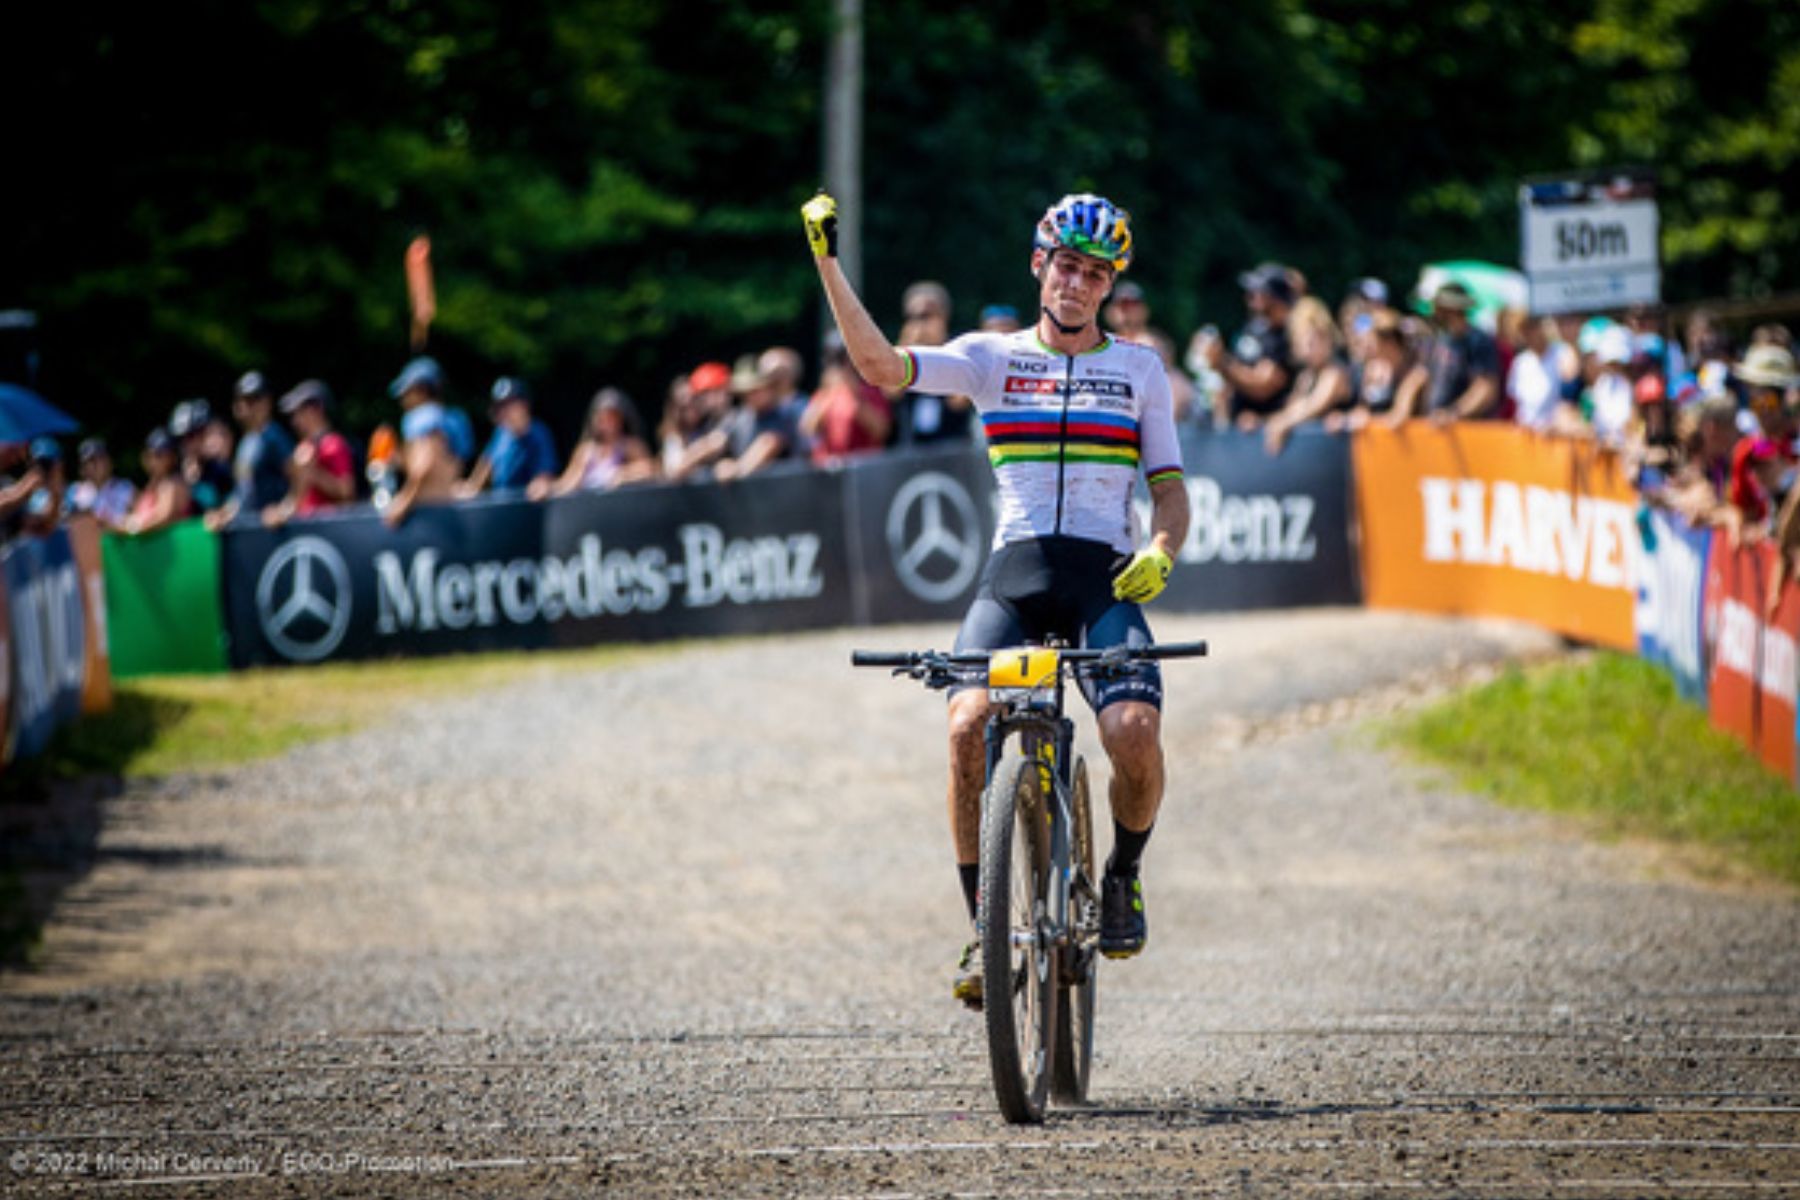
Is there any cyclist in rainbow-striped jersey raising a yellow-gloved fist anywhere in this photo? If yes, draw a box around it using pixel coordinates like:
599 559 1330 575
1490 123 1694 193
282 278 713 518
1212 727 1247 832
801 193 1188 1007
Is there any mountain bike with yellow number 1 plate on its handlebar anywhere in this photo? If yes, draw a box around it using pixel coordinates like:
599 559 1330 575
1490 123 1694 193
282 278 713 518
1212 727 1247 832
850 642 1206 1124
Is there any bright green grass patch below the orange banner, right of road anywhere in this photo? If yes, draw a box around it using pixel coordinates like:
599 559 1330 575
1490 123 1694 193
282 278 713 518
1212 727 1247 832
1395 651 1800 885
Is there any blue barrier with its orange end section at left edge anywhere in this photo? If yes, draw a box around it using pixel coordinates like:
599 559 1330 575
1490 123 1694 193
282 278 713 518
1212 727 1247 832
0 518 112 761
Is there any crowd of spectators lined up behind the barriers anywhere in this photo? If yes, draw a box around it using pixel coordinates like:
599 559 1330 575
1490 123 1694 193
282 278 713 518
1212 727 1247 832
10 263 1800 568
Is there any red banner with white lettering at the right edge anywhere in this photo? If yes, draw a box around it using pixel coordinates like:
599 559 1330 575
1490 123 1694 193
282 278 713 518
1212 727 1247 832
1705 531 1800 781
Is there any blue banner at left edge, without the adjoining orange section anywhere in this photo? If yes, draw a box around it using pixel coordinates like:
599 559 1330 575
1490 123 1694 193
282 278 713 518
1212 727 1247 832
0 529 88 759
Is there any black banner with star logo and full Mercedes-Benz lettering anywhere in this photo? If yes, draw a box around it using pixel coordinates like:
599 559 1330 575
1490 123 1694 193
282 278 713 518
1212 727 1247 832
223 471 850 666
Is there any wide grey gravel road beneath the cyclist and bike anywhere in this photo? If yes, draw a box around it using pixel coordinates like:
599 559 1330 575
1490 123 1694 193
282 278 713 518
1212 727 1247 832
0 610 1800 1198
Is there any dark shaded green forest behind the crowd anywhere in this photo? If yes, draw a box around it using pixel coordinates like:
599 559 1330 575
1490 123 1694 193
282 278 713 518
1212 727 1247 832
0 0 1800 446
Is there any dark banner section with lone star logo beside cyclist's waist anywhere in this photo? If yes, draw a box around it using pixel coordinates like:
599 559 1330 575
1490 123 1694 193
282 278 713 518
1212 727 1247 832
842 448 994 624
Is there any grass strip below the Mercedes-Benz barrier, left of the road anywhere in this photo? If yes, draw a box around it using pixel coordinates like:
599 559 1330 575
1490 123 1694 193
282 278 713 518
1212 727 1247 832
7 644 673 788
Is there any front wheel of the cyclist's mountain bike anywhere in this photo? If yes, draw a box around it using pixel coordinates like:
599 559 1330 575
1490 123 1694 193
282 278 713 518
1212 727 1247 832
977 750 1057 1124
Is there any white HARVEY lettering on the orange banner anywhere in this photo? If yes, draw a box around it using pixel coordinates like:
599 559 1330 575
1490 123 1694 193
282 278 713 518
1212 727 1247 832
1418 477 1640 592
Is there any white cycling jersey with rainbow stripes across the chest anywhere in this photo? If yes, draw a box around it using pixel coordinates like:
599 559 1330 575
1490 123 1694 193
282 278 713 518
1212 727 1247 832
902 329 1181 554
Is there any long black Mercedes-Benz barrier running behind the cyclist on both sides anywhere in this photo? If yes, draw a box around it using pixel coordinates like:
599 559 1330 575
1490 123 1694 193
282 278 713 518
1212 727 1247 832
220 435 1359 667
